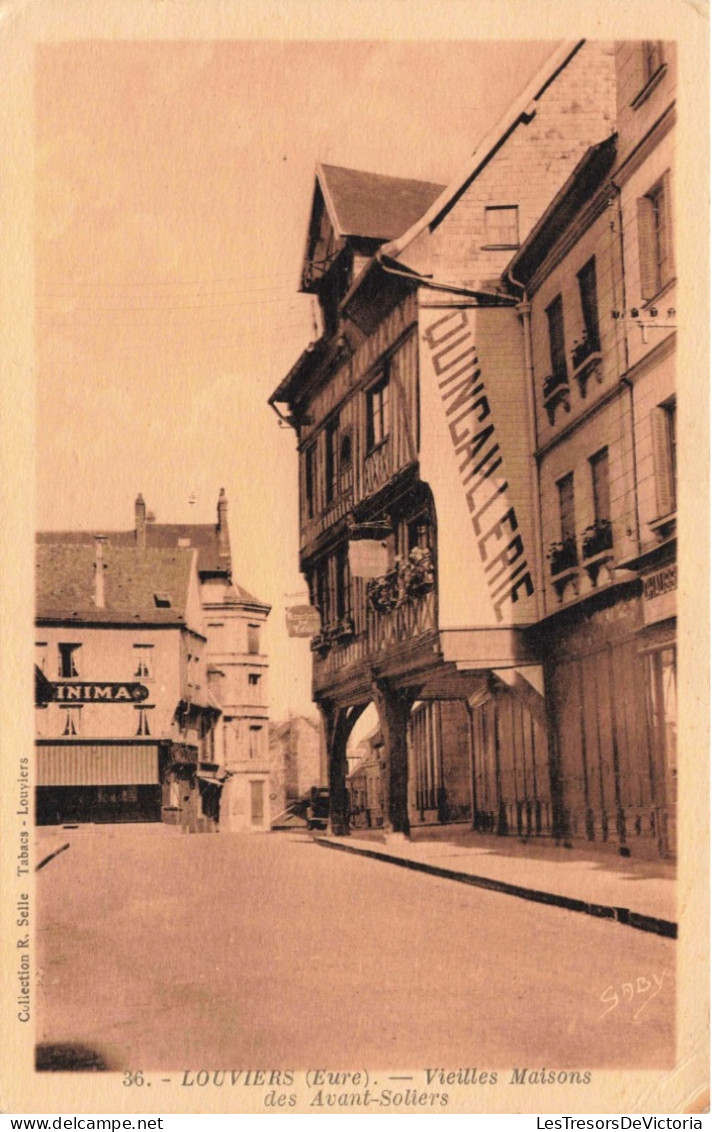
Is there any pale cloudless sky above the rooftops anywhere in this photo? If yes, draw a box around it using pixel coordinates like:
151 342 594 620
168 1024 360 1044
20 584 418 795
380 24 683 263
34 40 556 719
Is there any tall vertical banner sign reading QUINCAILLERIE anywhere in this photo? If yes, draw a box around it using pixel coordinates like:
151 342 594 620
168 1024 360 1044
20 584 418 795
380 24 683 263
420 307 537 629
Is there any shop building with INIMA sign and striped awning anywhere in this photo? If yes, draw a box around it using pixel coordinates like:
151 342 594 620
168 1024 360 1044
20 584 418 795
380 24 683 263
35 538 213 829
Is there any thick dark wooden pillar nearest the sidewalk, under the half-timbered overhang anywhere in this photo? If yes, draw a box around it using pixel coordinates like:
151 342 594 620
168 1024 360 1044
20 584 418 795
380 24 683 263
372 680 418 838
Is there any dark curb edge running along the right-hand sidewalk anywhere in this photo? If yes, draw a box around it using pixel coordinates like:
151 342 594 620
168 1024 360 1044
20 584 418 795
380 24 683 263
315 838 677 940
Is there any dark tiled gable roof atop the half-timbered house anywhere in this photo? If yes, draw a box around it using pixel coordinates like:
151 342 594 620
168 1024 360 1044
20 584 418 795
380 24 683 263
319 165 444 240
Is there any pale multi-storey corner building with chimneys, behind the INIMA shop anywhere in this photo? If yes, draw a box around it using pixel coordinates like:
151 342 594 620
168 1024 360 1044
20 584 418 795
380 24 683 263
37 490 269 832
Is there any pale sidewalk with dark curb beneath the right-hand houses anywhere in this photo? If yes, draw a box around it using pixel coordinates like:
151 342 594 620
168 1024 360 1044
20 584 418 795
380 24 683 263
317 825 677 938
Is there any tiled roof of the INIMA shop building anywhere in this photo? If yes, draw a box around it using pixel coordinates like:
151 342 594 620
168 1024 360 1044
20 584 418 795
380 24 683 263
36 541 195 625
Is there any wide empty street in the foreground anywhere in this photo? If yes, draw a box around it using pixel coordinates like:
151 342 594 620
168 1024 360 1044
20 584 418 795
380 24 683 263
35 825 676 1071
